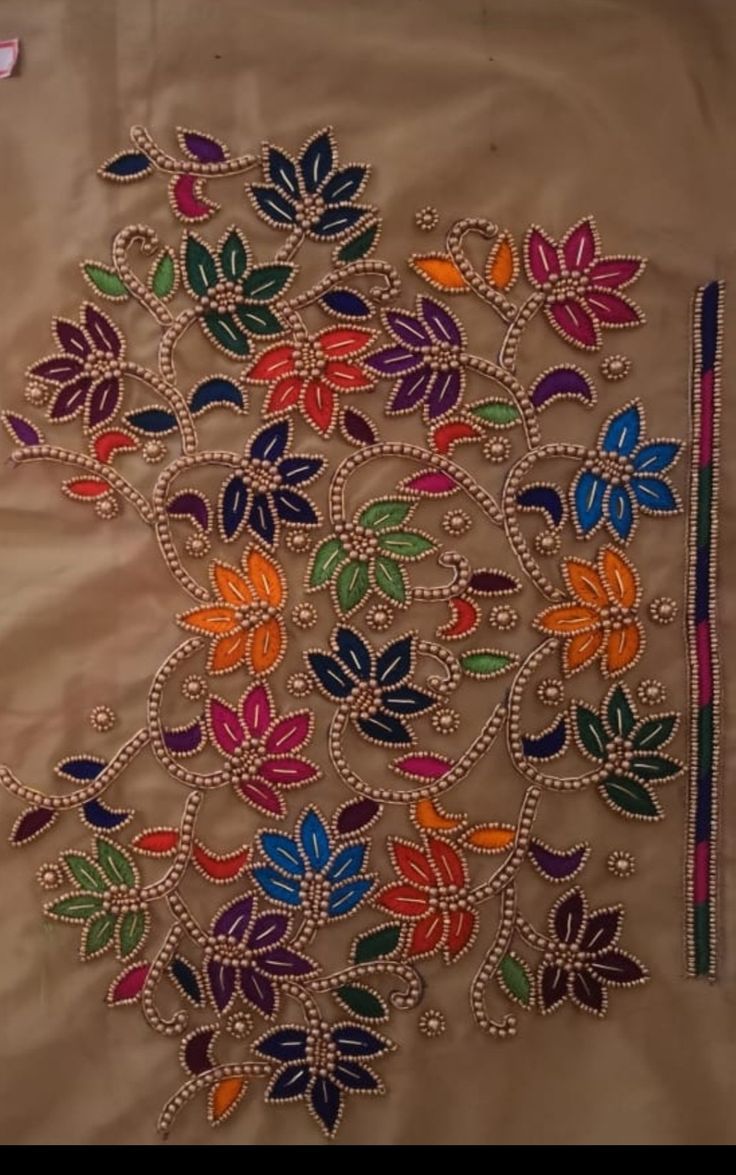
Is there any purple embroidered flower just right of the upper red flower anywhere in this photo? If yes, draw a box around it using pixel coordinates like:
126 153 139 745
363 295 466 423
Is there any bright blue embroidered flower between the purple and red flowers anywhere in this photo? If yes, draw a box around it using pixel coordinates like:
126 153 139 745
253 808 375 921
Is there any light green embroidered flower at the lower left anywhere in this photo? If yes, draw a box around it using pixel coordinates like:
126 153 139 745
46 837 150 960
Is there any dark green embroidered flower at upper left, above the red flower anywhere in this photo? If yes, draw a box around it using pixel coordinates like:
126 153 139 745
182 227 295 358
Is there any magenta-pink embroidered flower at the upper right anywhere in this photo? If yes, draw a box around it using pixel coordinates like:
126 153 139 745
524 217 645 351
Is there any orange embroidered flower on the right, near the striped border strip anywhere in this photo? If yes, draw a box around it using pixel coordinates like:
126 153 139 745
535 546 644 677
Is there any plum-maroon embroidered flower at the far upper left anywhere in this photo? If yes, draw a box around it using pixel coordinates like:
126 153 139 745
28 303 125 429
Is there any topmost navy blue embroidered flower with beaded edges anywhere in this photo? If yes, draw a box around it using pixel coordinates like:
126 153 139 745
248 130 372 241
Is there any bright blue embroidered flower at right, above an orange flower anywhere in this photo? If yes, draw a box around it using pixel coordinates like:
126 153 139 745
570 402 682 543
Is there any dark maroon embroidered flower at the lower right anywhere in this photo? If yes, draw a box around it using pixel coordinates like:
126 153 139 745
537 888 649 1016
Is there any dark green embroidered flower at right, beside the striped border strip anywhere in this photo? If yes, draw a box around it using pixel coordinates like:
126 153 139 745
574 685 683 820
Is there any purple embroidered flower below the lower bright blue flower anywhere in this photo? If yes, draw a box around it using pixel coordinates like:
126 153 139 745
205 894 315 1019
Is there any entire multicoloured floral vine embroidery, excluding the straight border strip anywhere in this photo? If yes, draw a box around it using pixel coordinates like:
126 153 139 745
0 127 684 1137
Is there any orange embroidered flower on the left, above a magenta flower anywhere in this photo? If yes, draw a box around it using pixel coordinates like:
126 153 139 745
178 548 286 677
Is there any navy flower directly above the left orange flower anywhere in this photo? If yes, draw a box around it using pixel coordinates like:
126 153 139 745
218 421 324 546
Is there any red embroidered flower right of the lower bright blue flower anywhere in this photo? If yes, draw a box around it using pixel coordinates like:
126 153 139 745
376 837 477 962
